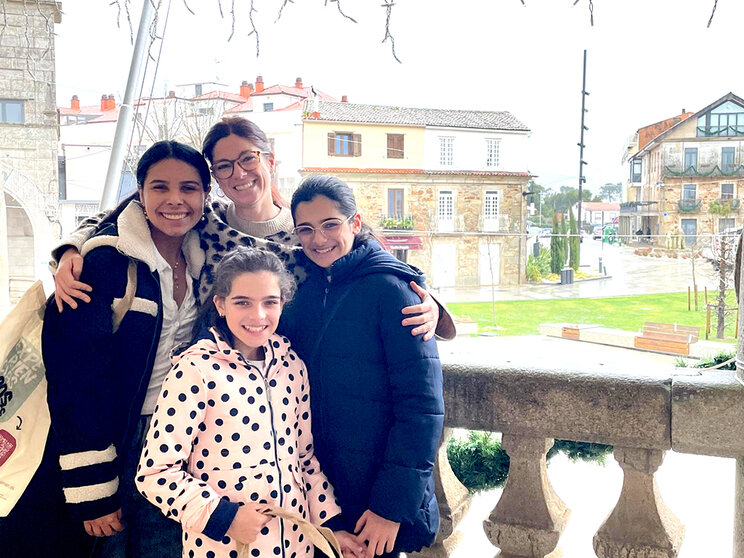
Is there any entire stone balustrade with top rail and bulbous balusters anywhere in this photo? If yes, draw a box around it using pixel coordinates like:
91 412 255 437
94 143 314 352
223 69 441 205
415 358 744 558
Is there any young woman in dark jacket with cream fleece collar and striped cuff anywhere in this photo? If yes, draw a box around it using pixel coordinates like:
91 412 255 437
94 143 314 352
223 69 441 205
42 141 210 558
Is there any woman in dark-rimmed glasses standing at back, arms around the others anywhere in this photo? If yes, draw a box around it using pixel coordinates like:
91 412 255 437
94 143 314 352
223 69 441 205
55 117 448 339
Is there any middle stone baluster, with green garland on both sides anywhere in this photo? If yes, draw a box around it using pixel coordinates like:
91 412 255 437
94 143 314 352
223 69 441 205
483 433 570 558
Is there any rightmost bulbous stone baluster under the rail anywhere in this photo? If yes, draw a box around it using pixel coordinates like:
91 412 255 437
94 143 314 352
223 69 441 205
594 447 685 558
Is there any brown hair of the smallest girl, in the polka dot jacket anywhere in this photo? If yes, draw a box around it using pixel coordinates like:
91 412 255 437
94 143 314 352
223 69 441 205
193 246 297 346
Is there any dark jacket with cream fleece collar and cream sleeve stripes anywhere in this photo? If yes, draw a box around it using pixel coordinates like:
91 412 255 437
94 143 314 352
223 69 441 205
42 201 204 520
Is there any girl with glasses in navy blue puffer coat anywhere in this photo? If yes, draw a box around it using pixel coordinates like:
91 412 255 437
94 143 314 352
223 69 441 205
282 176 444 556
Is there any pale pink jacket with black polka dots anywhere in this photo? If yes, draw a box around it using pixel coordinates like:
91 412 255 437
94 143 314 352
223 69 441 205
136 330 341 558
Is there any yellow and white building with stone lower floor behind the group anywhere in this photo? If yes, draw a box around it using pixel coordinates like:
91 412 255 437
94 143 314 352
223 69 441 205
302 102 530 288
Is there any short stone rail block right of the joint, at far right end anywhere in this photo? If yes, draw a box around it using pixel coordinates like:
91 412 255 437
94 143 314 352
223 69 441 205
672 370 744 457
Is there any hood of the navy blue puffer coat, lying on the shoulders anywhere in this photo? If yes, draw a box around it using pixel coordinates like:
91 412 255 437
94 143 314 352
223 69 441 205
315 239 426 287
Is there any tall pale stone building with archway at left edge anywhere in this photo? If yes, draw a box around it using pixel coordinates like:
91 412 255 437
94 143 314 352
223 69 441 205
0 0 61 304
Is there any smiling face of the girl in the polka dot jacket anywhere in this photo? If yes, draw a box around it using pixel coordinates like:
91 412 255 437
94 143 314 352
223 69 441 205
213 271 283 360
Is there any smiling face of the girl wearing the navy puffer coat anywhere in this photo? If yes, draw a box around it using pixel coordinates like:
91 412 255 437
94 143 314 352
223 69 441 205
294 196 362 267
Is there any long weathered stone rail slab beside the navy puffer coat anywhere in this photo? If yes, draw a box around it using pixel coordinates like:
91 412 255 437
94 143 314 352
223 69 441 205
444 356 671 449
